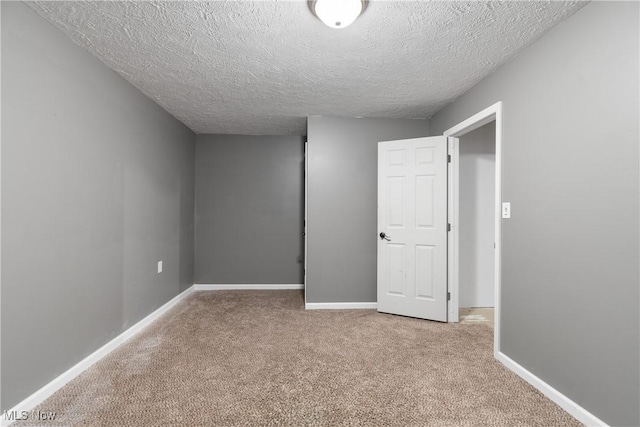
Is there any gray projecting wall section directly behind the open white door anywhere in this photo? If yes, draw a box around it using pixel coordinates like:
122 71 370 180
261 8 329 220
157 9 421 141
306 116 428 303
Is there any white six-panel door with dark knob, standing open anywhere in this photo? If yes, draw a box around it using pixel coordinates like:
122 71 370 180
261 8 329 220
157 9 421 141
377 136 447 322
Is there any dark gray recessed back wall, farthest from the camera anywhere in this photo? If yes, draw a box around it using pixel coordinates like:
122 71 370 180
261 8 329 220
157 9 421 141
195 135 304 284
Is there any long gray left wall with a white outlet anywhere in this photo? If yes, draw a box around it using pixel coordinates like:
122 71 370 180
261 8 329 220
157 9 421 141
0 2 195 411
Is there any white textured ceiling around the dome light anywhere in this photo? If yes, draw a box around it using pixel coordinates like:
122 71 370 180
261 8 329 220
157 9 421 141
28 0 585 135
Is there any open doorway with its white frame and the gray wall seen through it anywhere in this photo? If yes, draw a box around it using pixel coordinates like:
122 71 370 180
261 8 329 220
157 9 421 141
444 102 502 355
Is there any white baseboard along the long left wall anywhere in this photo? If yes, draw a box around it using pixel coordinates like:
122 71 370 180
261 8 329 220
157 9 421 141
0 286 193 426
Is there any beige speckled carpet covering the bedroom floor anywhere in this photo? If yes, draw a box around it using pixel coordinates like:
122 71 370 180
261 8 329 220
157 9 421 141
15 291 581 426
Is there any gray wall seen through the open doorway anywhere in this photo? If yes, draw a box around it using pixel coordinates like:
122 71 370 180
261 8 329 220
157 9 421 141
458 122 496 307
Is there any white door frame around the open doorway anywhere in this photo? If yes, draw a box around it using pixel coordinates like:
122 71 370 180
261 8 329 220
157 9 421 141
444 102 502 357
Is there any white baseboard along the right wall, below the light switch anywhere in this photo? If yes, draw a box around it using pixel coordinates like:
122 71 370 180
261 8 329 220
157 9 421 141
497 352 607 427
